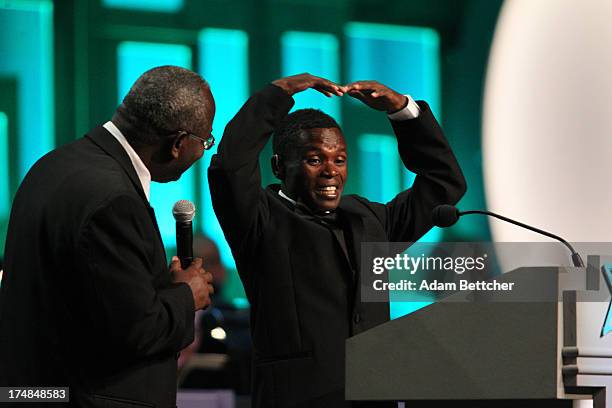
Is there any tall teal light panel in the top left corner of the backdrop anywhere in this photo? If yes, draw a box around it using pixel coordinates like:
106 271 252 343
0 0 55 179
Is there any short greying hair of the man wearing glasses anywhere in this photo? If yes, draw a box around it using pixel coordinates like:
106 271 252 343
117 65 214 145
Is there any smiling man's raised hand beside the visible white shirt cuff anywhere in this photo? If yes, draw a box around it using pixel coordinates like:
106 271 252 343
343 81 408 113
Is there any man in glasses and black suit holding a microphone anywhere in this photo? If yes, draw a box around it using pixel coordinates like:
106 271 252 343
0 66 215 407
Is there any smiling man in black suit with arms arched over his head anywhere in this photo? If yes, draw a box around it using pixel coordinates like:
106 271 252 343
209 74 466 407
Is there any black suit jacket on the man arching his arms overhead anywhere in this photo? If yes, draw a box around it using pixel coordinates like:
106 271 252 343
209 85 465 408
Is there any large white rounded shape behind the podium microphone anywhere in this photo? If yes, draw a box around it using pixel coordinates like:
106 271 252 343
483 0 612 242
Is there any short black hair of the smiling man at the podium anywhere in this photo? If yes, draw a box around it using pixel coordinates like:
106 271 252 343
272 109 340 157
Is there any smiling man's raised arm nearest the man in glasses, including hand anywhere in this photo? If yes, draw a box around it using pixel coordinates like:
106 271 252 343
208 74 342 251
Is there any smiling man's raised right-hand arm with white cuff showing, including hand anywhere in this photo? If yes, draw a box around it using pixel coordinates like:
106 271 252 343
345 81 466 242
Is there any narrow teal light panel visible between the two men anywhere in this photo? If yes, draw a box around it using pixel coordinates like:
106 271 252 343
198 28 249 270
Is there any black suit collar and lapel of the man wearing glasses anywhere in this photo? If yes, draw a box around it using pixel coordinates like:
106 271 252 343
85 126 164 248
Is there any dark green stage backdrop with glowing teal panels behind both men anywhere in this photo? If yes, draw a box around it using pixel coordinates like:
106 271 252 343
0 0 501 317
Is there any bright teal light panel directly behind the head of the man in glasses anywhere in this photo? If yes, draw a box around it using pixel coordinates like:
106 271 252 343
117 42 191 248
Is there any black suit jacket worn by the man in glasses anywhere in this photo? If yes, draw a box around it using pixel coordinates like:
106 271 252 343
0 127 194 407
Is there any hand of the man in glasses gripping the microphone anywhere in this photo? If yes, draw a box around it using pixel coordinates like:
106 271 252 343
170 256 214 310
